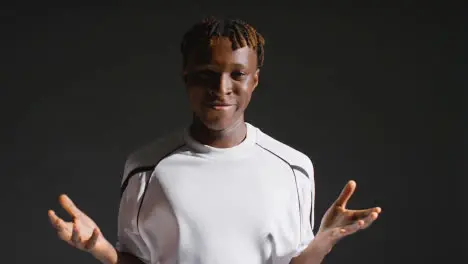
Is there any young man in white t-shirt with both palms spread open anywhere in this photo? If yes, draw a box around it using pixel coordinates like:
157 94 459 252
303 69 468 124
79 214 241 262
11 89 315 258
49 17 381 264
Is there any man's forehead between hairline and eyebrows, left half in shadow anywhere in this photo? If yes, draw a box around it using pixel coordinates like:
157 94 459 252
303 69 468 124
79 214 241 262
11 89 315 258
187 37 257 69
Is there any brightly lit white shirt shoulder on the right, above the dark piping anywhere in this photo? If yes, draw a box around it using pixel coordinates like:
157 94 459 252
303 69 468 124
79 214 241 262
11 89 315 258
252 124 314 179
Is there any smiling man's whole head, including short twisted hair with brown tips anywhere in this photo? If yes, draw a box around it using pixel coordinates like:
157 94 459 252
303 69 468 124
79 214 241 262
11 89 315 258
181 17 265 130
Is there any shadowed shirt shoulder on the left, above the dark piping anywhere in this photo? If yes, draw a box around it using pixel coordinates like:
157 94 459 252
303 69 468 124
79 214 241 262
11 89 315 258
122 131 185 185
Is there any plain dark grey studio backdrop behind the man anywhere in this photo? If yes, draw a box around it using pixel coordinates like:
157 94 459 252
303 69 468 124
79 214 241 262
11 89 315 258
0 2 468 264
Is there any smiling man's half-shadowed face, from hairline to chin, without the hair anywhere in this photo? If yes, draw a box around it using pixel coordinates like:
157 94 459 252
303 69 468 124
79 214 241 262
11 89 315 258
184 37 259 130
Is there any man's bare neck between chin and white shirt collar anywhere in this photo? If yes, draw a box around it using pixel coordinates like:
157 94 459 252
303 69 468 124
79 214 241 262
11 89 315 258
190 118 247 148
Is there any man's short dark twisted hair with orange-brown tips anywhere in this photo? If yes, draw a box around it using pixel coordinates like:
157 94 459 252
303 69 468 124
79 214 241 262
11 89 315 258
180 16 265 68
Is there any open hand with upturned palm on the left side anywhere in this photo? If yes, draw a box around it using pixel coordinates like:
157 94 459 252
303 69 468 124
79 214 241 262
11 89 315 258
48 194 118 263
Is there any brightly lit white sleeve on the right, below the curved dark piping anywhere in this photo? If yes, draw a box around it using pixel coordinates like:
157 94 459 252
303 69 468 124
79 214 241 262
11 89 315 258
296 158 315 256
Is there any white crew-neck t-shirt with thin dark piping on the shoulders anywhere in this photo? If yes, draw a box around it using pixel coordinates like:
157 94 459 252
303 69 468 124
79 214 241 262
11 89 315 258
117 123 315 264
